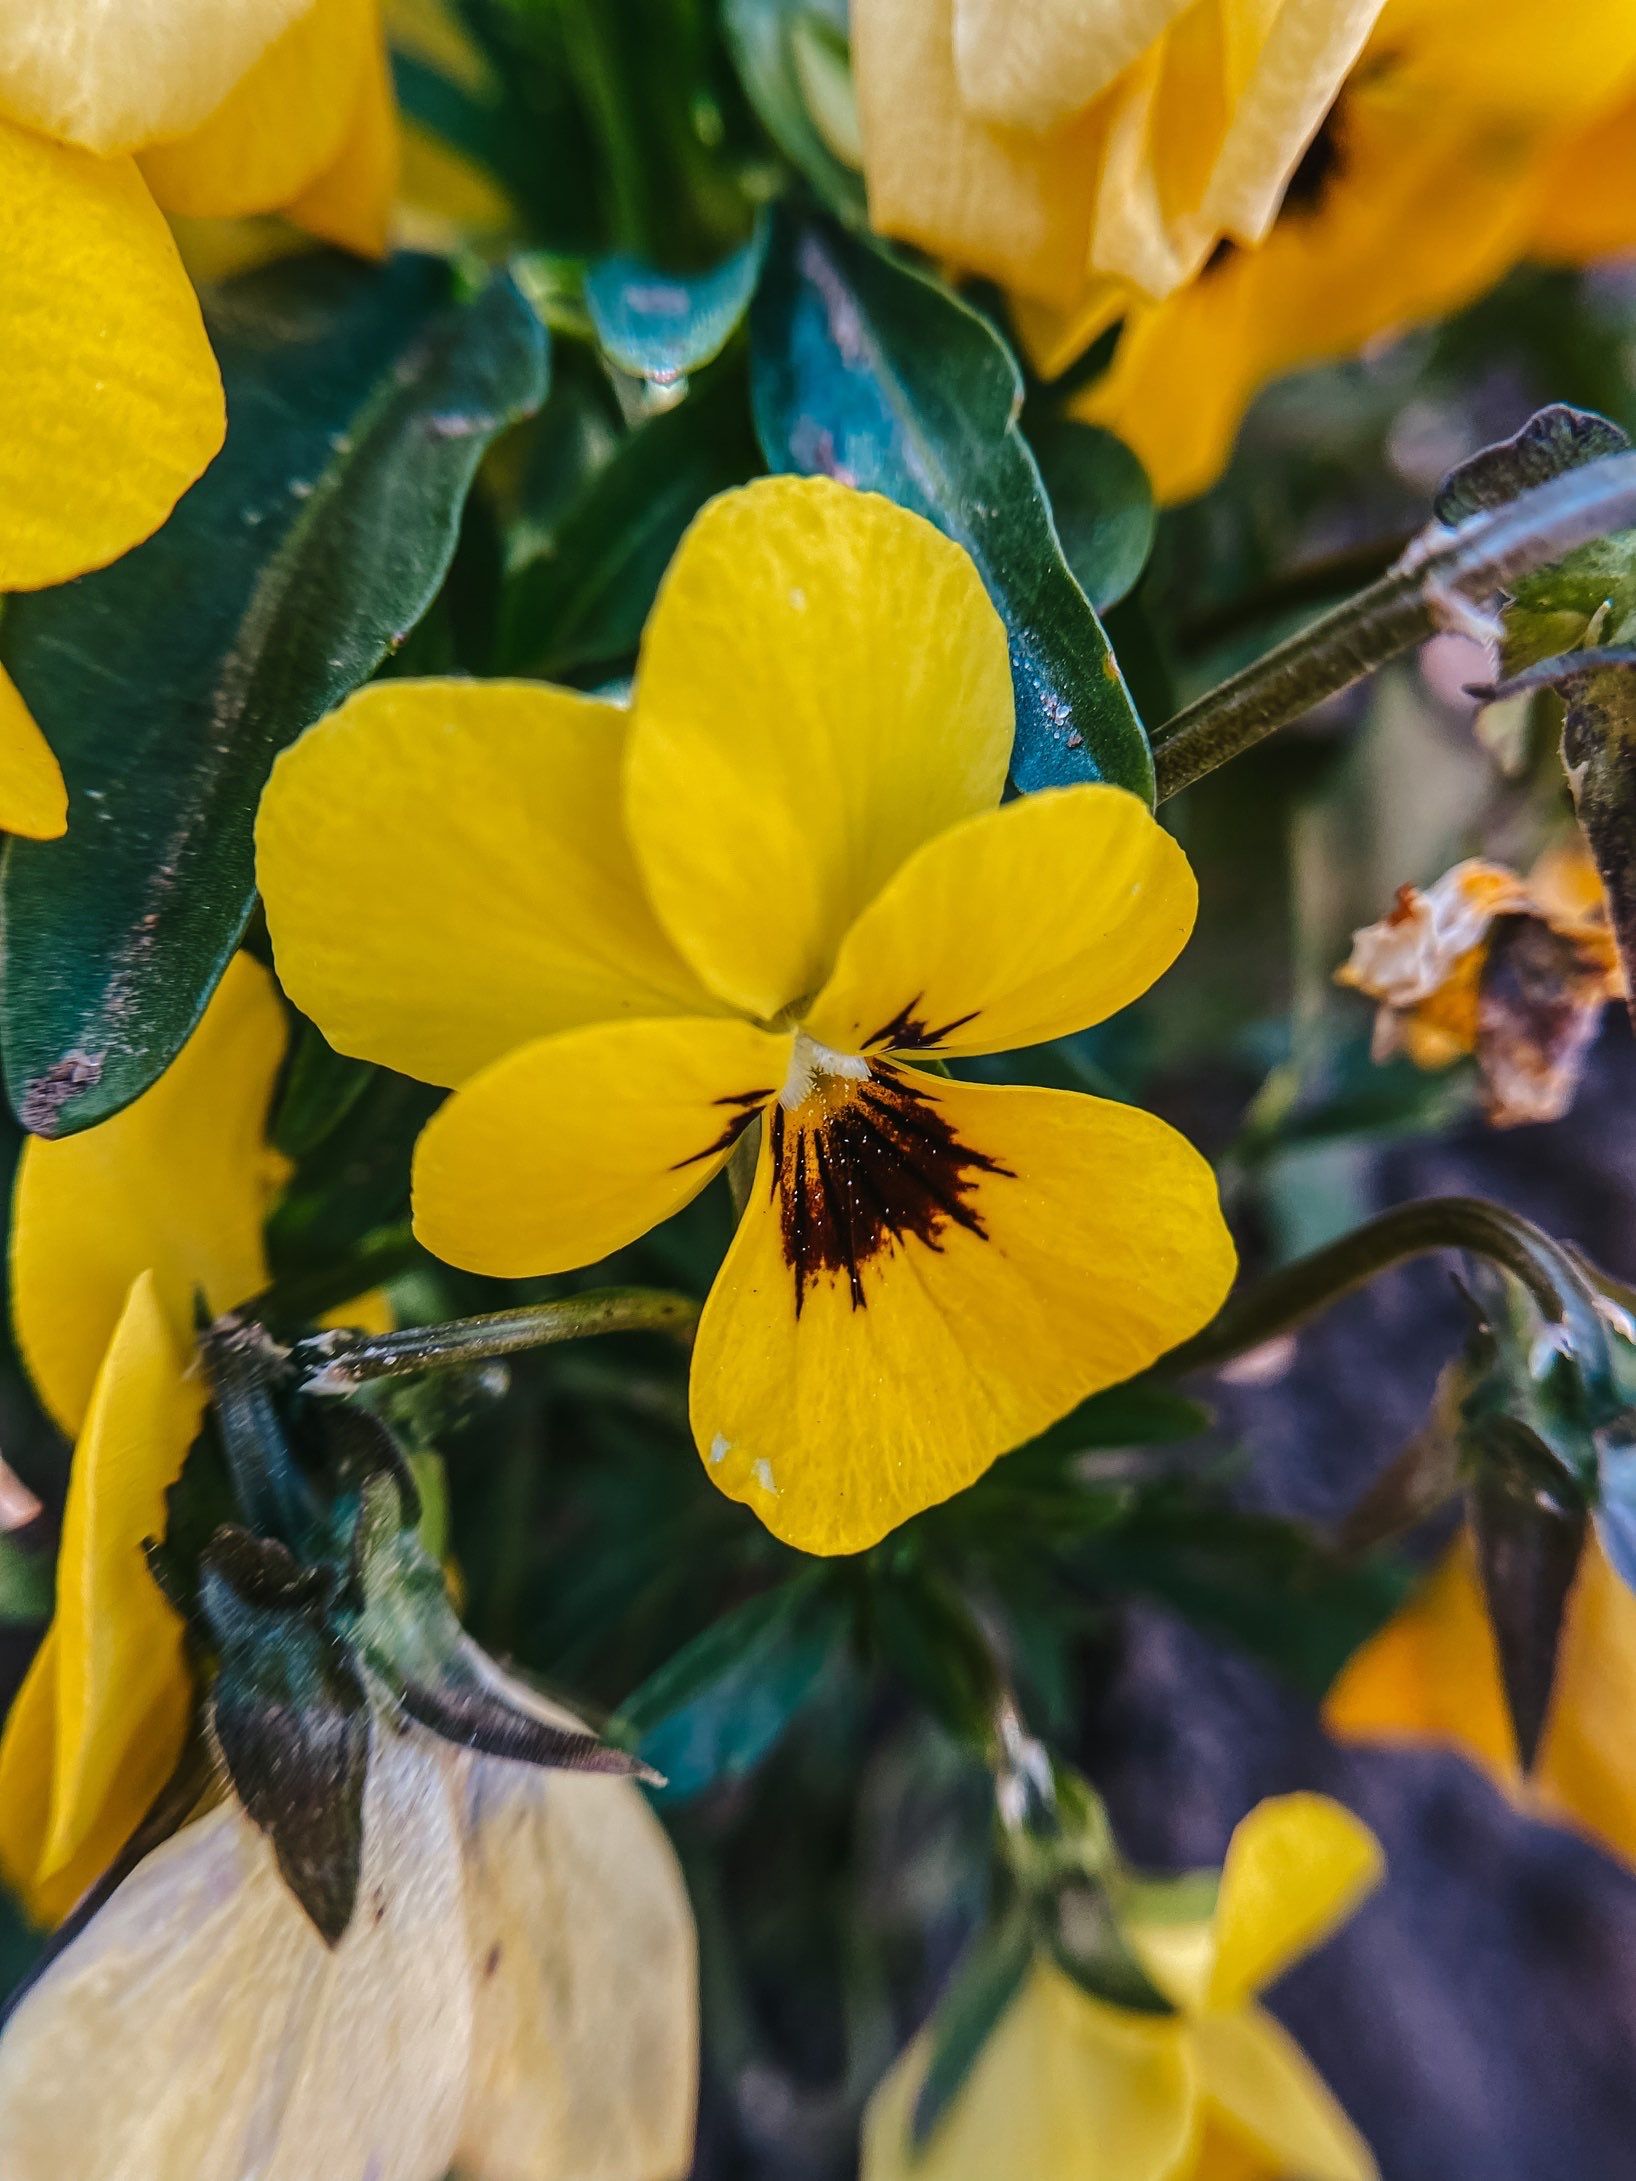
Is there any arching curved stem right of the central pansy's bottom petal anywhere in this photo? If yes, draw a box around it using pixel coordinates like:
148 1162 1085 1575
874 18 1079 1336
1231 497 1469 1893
1165 1197 1605 1372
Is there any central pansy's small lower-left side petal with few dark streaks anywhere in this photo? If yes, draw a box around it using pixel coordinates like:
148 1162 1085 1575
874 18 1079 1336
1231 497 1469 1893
414 1021 792 1280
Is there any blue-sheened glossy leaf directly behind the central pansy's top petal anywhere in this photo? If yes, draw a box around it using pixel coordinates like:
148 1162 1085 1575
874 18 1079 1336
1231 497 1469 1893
750 220 1154 803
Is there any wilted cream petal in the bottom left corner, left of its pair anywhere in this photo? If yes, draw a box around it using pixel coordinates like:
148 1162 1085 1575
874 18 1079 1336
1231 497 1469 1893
0 1727 471 2181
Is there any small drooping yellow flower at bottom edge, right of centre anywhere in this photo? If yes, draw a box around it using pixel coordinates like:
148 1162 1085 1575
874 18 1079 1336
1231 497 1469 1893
862 1795 1383 2181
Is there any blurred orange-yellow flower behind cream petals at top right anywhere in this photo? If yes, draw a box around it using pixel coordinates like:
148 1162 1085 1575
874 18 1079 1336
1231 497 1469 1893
1077 0 1636 502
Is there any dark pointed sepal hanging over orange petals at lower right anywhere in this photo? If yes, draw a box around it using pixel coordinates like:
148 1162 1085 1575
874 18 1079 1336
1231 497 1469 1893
1470 1429 1586 1771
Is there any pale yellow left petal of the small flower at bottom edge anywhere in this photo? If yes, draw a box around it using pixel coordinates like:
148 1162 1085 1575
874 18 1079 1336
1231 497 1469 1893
862 1967 1195 2181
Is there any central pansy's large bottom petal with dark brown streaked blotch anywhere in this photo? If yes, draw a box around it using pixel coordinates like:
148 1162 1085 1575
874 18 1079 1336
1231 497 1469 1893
691 1064 1232 1553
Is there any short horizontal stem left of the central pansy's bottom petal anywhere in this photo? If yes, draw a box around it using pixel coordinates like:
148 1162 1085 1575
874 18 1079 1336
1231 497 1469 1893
290 1287 698 1394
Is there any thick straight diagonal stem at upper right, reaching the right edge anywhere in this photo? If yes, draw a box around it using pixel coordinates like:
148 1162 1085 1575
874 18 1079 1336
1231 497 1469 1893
1154 451 1636 803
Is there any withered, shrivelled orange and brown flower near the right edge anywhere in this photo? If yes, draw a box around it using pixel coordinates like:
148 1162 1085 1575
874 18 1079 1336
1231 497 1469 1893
1335 833 1625 1128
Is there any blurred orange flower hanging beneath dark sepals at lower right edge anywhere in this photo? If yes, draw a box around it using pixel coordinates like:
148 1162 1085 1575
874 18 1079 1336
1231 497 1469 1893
1324 1531 1636 1867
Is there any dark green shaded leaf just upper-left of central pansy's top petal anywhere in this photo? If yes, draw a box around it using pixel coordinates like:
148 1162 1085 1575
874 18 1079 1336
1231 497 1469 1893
500 360 757 678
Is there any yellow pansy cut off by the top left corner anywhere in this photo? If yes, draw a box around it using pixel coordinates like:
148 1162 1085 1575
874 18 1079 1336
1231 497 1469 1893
0 0 395 838
